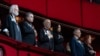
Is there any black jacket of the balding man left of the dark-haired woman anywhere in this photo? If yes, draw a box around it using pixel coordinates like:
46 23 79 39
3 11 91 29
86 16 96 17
39 28 54 50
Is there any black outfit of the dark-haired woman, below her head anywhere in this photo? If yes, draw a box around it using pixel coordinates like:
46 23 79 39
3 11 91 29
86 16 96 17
54 33 65 53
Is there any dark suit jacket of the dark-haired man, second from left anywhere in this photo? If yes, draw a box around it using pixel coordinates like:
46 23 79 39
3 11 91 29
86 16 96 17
20 22 36 45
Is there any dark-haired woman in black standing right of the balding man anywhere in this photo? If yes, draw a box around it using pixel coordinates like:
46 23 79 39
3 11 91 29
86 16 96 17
54 25 65 53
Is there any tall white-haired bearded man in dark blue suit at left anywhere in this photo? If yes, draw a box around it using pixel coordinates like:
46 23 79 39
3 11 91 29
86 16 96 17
3 4 22 41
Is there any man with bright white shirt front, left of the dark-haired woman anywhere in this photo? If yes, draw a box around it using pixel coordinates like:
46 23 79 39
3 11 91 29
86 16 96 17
39 19 54 51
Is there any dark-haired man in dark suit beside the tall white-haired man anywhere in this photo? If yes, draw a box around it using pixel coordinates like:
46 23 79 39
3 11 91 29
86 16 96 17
20 12 37 45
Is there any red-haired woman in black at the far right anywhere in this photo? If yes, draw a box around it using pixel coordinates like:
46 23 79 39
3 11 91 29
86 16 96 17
84 35 96 56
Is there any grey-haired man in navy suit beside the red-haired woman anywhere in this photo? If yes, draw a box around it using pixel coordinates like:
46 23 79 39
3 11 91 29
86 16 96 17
70 28 85 56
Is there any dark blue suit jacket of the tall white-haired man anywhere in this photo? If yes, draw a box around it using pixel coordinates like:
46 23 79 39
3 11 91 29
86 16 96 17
4 14 22 41
